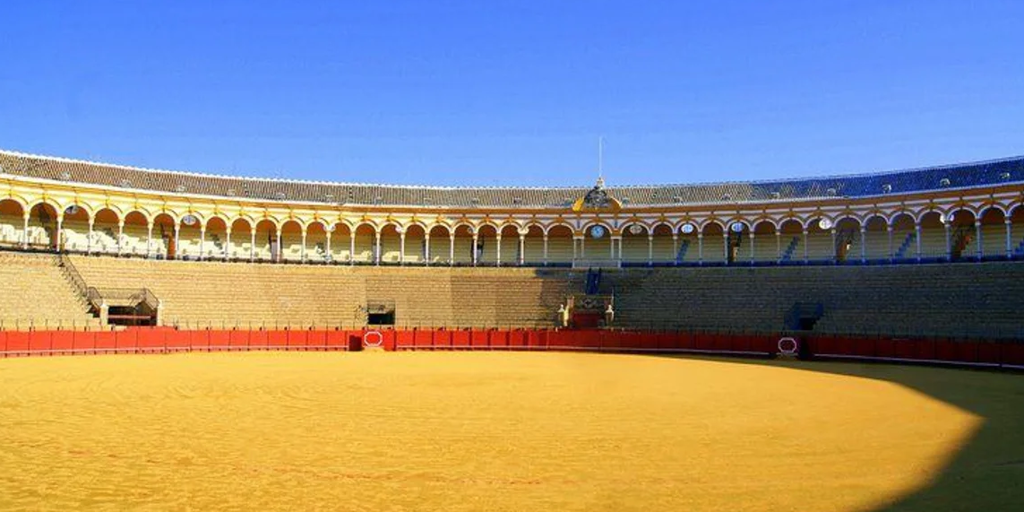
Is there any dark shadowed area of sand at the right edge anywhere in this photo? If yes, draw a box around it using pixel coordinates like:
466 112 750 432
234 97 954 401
651 356 1024 512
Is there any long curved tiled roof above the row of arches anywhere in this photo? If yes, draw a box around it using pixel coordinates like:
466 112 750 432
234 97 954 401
0 151 1024 208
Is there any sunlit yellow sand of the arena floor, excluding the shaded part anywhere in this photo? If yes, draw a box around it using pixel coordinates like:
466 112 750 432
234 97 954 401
0 352 980 512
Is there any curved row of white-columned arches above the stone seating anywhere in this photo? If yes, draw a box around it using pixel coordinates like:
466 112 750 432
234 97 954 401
0 199 1024 265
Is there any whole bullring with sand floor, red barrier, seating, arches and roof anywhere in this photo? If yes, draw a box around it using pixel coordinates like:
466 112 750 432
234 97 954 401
0 152 1024 511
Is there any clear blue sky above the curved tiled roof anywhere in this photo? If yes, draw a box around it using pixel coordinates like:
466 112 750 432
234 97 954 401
0 0 1024 185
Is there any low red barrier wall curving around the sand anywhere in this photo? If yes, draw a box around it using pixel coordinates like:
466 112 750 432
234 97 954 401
0 328 1024 368
